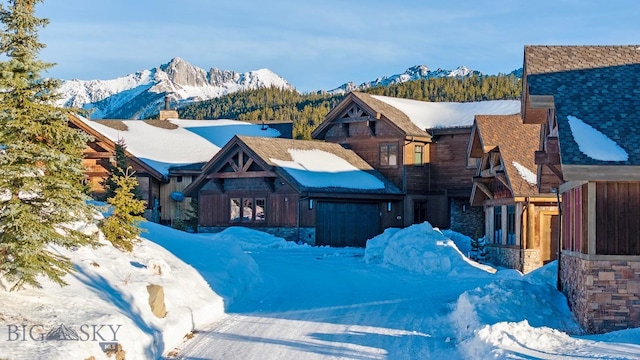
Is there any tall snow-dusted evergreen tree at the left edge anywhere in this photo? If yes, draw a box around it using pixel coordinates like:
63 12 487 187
0 0 96 290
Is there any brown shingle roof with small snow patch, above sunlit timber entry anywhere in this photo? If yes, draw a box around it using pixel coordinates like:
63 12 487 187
475 114 540 196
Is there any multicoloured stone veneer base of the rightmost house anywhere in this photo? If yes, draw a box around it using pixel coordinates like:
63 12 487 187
560 253 640 334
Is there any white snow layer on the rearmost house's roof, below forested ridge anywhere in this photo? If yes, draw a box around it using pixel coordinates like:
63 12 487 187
372 95 520 129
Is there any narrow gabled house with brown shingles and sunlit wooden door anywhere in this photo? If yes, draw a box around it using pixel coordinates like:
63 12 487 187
468 114 559 273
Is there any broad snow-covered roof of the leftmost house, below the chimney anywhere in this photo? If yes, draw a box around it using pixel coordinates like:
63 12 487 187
76 115 280 176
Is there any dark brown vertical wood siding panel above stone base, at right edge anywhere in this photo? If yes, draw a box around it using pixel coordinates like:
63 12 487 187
596 182 640 255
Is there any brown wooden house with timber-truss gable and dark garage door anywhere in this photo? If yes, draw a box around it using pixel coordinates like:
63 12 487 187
185 136 402 246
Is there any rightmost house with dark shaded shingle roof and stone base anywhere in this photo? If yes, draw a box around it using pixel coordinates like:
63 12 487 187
522 45 640 333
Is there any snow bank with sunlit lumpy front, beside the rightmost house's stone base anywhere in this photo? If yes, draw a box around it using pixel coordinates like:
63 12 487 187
449 265 582 359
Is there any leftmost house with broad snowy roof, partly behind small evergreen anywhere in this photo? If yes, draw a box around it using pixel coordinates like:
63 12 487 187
69 115 280 223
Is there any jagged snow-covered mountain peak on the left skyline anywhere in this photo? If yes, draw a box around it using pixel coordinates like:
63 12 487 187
58 57 294 119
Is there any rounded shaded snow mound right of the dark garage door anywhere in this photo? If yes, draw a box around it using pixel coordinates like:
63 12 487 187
365 222 495 276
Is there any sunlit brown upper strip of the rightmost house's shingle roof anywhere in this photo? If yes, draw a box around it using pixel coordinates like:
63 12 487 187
524 45 640 75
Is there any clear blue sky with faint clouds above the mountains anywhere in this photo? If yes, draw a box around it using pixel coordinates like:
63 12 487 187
36 0 640 91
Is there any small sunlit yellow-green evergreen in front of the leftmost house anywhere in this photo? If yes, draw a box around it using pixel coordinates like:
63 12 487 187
100 167 147 251
